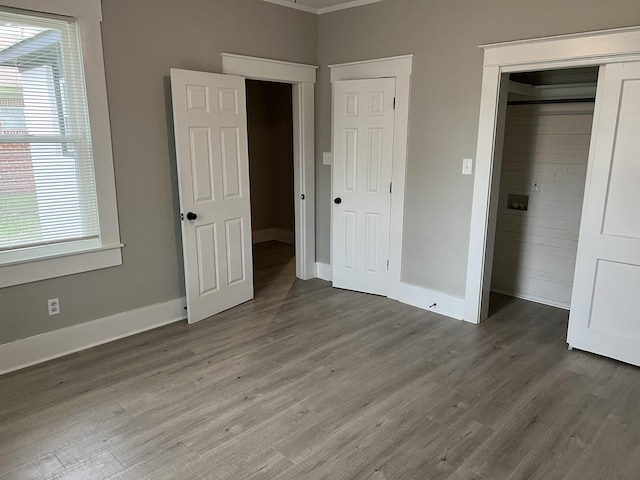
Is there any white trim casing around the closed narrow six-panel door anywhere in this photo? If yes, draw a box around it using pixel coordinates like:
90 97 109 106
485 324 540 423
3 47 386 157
329 54 413 300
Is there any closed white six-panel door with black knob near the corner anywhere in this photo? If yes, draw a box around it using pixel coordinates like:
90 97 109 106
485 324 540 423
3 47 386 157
332 78 395 295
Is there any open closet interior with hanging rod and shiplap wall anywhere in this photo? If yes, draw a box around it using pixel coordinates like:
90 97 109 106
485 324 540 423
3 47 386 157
485 66 599 315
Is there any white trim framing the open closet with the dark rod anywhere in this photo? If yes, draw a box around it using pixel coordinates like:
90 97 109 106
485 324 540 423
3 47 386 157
463 27 640 323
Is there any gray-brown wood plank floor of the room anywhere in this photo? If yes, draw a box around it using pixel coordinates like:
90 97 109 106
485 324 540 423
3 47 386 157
0 243 640 480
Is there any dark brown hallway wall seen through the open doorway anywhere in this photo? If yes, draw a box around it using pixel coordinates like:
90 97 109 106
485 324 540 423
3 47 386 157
246 80 295 232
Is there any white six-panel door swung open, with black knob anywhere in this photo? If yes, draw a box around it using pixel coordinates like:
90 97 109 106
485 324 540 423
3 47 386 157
171 69 253 323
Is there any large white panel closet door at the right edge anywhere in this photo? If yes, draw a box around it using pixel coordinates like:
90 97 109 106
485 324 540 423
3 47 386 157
568 63 640 365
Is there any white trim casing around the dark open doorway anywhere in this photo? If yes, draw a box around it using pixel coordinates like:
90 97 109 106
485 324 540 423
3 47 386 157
222 53 318 280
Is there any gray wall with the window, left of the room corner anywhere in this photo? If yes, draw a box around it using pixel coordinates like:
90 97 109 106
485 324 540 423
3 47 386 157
0 0 318 344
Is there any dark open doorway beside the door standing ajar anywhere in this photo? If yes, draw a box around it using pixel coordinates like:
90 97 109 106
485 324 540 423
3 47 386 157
245 79 296 295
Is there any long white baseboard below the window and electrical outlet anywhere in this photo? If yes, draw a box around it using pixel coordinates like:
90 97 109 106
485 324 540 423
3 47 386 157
0 298 186 375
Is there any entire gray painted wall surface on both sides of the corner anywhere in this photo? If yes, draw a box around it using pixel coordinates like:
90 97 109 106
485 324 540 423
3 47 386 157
5 0 640 343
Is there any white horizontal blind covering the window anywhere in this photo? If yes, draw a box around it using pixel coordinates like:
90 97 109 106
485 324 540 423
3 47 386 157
0 11 100 252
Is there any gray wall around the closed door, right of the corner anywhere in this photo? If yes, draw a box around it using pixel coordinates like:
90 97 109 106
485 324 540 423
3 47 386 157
316 0 640 297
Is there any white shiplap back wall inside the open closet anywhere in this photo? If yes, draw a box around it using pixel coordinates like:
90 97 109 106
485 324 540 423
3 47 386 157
491 103 593 309
